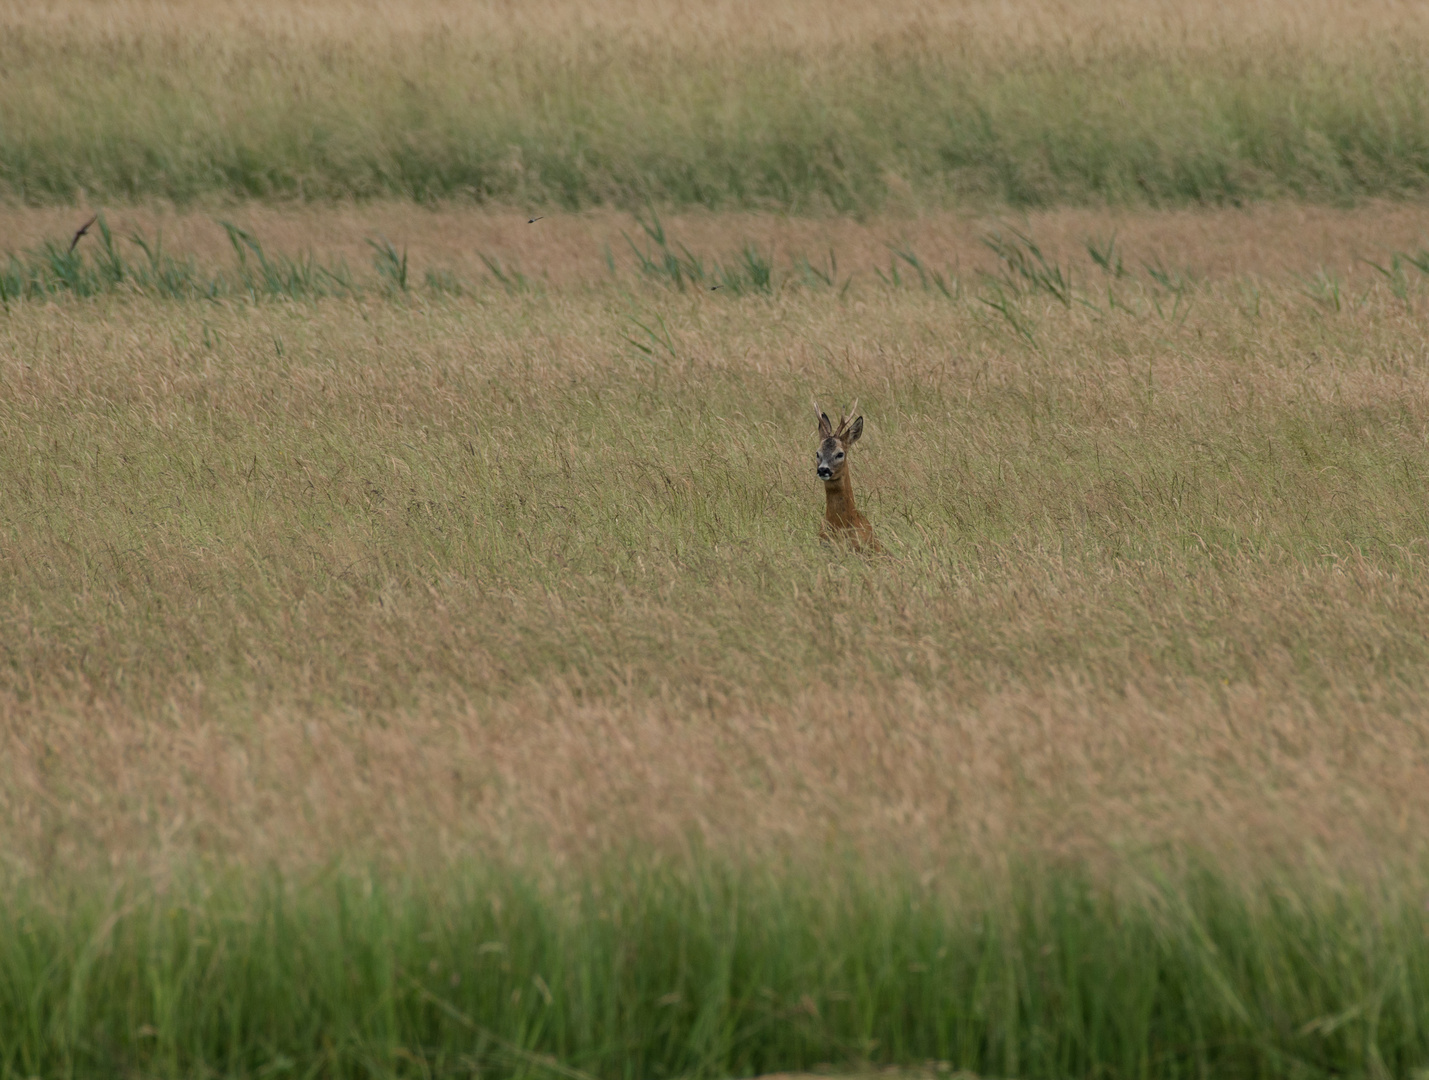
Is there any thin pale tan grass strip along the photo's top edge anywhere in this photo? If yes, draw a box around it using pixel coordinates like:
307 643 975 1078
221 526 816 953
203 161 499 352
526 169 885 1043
11 0 1429 63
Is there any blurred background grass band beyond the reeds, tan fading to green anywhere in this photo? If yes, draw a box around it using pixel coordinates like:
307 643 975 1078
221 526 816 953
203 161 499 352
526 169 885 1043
8 3 1429 213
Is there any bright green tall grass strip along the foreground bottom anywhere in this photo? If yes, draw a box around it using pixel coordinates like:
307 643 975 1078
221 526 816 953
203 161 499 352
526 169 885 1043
0 863 1429 1080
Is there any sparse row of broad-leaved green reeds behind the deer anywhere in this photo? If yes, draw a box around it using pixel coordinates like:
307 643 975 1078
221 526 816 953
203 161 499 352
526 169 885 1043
16 213 1429 337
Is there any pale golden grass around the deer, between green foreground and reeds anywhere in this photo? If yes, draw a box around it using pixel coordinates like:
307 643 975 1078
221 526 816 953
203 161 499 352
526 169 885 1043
8 207 1429 873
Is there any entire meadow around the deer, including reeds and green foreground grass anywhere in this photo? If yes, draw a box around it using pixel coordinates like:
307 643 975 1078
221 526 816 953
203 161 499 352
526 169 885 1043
0 203 1429 1080
